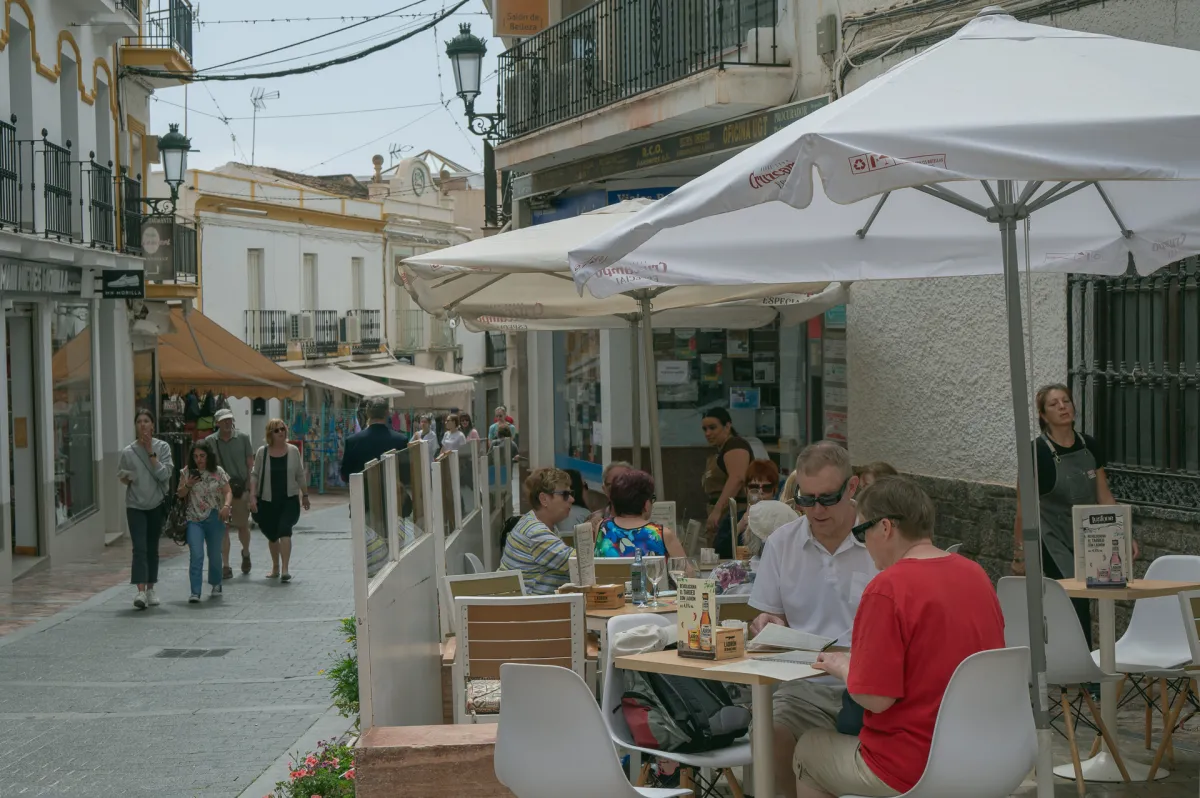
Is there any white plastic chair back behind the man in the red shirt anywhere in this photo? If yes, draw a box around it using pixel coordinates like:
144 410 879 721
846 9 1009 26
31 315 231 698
906 648 1037 798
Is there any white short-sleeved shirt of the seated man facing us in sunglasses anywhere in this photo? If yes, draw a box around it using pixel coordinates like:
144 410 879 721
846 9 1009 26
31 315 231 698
750 517 878 646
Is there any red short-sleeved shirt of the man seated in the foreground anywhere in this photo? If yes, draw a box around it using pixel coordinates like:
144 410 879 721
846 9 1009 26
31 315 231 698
849 554 1004 792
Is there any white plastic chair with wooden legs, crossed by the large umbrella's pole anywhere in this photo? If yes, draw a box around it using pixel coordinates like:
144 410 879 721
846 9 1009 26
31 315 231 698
996 576 1129 796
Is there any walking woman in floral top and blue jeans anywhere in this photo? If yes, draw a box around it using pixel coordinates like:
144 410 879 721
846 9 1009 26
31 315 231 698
179 440 233 604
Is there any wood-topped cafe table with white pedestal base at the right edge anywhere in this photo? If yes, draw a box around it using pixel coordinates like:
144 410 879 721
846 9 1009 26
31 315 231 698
1054 580 1200 782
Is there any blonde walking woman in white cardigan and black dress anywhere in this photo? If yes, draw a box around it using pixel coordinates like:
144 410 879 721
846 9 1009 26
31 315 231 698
250 419 308 582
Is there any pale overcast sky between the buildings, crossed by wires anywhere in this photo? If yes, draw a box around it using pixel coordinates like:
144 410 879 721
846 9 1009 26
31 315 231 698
150 0 502 175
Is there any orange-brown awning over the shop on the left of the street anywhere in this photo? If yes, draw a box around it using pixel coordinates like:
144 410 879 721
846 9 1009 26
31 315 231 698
150 307 304 400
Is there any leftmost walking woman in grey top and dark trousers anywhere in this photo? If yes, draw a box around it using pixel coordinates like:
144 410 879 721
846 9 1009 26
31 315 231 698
116 410 174 610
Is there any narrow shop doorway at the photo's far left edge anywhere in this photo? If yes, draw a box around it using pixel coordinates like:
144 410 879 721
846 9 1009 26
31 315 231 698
5 305 42 557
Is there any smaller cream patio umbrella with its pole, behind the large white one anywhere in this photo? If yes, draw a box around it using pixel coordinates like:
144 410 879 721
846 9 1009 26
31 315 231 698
396 199 845 486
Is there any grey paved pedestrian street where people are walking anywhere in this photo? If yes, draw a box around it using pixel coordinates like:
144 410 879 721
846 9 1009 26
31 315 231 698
0 499 354 798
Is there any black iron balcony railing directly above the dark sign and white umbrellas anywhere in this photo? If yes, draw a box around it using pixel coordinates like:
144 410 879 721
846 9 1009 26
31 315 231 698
499 0 788 138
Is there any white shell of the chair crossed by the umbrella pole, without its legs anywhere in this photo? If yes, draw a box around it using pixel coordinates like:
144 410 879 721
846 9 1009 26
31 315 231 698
996 576 1103 685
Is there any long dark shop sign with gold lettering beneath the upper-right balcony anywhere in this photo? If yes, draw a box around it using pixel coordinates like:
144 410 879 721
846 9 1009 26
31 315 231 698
512 95 830 199
